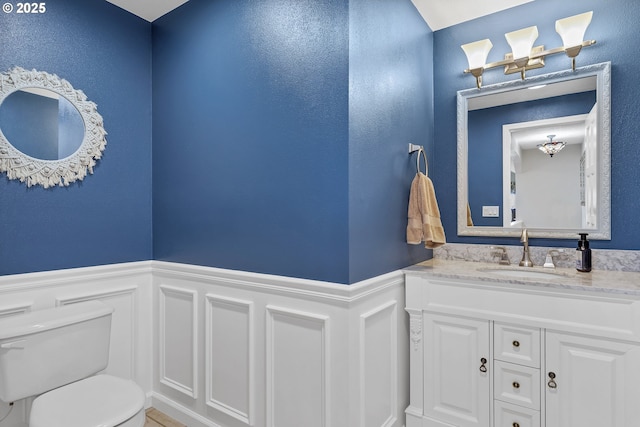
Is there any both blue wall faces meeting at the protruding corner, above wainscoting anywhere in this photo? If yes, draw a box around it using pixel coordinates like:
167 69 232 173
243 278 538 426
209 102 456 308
153 0 432 283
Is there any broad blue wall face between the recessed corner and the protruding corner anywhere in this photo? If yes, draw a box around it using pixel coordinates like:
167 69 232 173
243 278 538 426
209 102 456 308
153 0 349 281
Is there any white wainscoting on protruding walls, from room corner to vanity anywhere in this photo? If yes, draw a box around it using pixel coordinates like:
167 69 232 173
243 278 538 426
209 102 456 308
152 261 409 427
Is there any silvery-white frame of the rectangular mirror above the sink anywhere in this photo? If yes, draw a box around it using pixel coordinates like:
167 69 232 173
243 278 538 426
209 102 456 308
457 62 611 240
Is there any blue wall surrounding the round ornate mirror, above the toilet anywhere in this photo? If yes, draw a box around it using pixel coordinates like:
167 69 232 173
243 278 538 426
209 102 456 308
0 0 152 275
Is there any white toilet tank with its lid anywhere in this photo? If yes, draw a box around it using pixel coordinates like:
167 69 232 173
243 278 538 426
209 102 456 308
0 301 113 402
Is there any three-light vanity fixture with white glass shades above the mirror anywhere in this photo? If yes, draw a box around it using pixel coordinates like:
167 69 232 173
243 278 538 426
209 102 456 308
461 11 596 89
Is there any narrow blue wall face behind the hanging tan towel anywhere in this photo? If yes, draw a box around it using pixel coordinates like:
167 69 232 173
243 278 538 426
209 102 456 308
349 0 438 283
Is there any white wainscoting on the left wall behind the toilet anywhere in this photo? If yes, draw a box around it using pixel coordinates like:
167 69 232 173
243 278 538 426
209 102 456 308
0 261 154 427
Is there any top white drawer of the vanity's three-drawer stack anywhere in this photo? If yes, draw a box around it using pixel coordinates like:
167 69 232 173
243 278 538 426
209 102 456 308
493 322 540 368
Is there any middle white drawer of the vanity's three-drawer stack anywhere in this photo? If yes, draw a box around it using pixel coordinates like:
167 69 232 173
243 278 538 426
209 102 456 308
493 360 540 410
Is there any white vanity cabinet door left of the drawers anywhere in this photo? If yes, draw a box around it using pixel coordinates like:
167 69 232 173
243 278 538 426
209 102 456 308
424 313 492 427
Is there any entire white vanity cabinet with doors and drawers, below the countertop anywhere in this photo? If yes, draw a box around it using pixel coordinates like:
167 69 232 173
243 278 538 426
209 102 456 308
406 272 640 427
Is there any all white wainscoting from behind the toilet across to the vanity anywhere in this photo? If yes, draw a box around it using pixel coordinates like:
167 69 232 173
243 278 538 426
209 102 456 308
0 261 409 427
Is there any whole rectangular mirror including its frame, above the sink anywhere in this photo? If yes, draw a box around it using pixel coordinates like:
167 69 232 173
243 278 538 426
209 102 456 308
457 62 611 240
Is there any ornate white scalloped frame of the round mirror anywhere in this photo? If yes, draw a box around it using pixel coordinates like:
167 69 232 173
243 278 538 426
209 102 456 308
0 67 107 188
